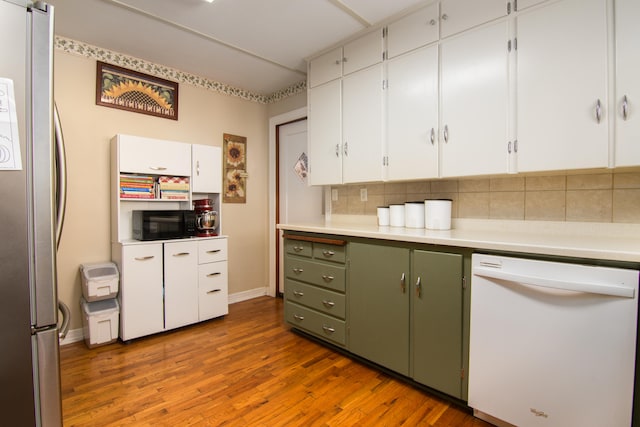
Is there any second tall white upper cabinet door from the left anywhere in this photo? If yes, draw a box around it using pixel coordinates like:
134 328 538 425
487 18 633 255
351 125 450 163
342 64 383 183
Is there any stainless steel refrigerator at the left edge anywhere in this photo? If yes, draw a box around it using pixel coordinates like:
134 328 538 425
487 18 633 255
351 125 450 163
0 0 62 427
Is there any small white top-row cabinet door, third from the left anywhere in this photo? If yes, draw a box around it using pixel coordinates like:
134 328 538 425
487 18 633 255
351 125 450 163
387 3 439 58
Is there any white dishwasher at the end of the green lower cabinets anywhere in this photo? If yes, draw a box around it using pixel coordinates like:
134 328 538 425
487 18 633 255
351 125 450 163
468 254 638 427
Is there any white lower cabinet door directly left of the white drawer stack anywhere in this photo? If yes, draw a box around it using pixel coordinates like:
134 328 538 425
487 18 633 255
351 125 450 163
164 242 198 329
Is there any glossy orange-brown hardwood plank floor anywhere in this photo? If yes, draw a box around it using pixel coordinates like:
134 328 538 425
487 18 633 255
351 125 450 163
60 297 489 427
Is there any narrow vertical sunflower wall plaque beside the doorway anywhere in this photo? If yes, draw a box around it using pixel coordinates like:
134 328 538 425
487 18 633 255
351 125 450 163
222 133 247 203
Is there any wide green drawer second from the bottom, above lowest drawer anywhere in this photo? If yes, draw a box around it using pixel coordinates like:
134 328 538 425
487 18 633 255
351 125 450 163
284 279 346 319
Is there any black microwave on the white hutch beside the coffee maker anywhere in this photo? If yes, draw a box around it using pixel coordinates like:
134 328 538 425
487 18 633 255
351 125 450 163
131 210 196 240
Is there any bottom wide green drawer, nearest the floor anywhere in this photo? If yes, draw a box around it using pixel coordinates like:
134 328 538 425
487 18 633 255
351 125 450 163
284 301 346 346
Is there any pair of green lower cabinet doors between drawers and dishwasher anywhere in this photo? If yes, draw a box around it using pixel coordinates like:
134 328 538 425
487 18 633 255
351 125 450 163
347 242 468 400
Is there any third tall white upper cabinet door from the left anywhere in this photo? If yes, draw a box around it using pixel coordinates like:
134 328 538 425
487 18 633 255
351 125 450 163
387 45 438 180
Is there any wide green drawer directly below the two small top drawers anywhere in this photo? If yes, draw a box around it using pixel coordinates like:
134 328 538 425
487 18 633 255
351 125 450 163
285 257 345 292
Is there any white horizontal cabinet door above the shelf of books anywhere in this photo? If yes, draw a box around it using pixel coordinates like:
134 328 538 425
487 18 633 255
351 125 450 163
118 135 191 176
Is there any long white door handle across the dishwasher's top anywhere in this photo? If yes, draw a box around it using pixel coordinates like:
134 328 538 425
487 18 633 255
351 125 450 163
473 267 635 298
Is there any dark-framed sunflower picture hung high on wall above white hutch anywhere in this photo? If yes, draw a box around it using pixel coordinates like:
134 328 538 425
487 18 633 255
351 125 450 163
96 61 178 120
